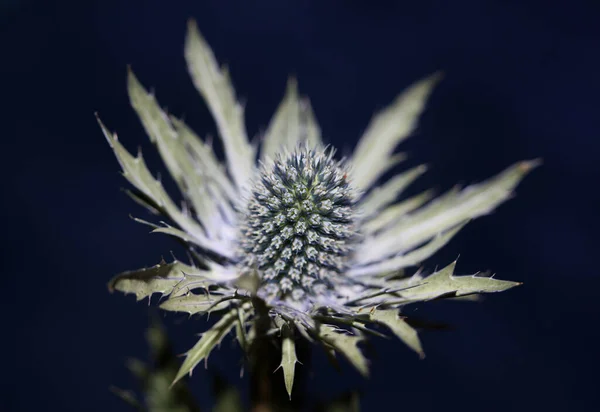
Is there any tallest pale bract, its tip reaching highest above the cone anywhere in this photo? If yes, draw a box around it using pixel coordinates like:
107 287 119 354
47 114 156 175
185 20 256 189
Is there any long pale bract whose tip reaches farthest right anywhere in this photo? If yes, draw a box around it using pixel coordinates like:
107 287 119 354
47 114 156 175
363 160 539 261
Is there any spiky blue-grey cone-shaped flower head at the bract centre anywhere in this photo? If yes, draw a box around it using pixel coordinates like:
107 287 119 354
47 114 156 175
240 146 356 301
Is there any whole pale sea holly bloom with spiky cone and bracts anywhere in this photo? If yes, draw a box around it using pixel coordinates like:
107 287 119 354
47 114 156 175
100 22 537 400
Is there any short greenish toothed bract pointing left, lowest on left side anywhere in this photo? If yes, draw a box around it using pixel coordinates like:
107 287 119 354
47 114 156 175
108 261 196 300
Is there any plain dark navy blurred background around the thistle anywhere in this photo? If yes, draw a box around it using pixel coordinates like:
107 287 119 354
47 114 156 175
0 0 600 411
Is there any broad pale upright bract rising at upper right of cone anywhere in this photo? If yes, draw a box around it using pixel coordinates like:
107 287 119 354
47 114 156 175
351 73 441 188
